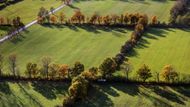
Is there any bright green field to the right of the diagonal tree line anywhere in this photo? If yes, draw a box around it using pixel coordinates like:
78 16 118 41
129 28 190 74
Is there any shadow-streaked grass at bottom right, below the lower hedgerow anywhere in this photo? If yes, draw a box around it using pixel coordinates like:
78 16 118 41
77 83 190 107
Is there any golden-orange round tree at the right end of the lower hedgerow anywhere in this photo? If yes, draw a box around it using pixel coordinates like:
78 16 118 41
161 65 178 82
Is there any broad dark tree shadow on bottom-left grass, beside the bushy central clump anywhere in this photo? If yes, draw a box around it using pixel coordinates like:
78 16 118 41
32 82 69 100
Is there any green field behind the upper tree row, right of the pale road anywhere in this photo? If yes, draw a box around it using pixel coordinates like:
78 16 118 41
63 0 174 22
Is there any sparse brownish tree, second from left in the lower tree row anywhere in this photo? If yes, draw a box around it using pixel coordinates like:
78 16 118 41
8 54 18 77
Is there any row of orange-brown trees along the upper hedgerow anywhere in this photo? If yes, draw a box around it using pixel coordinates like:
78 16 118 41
37 7 158 25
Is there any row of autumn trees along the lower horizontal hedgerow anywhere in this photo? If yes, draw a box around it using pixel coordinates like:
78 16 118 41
0 54 181 82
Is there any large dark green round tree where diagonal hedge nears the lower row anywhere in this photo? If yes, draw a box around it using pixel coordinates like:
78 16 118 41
99 58 117 78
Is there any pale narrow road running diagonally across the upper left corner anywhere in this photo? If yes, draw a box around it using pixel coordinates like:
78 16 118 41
0 0 72 44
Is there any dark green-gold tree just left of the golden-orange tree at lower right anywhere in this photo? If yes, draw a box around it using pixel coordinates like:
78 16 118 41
137 64 152 82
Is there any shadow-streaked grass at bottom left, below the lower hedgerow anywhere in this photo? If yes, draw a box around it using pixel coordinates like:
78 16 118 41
0 82 69 107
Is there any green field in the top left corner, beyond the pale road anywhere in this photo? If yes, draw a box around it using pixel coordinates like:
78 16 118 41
0 0 61 23
